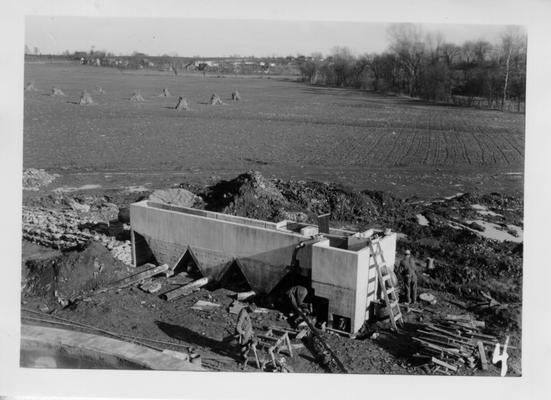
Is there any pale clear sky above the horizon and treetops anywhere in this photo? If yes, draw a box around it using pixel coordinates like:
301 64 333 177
25 16 504 57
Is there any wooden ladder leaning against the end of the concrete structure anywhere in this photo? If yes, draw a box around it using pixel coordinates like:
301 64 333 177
369 240 404 332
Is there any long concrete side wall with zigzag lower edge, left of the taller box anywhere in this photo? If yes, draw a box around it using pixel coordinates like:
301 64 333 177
130 201 316 293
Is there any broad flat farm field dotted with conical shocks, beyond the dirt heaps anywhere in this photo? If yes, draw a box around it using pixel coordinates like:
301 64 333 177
23 64 524 196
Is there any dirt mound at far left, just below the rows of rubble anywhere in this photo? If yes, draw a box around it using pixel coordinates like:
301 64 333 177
23 242 128 305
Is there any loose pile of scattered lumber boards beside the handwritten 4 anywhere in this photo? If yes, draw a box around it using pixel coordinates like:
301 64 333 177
413 315 504 375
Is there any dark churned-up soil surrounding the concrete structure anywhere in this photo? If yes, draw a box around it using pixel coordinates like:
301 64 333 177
22 171 523 375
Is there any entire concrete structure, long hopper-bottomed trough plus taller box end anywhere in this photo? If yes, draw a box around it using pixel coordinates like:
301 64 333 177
130 200 396 332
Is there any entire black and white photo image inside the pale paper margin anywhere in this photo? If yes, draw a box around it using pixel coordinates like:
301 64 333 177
0 2 549 397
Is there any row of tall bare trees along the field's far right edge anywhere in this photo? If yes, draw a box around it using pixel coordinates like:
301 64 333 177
299 24 526 112
